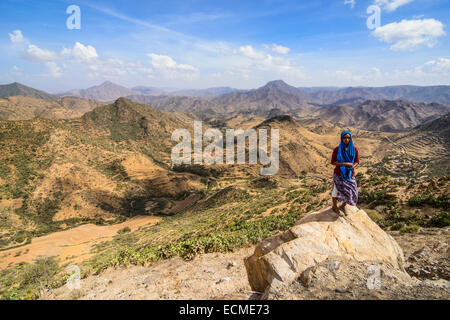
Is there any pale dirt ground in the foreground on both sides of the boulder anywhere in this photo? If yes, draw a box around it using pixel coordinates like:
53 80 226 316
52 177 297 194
41 228 450 300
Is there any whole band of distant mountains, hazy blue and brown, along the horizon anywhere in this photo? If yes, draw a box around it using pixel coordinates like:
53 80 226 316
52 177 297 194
0 80 450 132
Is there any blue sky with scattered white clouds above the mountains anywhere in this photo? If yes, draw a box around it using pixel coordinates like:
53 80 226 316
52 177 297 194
0 0 450 93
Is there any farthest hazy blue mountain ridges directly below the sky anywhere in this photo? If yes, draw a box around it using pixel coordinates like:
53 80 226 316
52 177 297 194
52 80 450 105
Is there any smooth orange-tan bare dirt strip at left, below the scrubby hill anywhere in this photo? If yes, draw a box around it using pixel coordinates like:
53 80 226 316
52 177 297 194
0 216 160 270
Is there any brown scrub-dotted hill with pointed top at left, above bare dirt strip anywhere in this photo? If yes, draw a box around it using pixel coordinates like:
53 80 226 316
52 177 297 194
0 99 209 254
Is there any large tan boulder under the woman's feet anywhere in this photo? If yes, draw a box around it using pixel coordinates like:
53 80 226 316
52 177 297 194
244 207 405 298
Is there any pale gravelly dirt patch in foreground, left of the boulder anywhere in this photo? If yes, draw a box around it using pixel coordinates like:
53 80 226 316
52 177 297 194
41 246 254 300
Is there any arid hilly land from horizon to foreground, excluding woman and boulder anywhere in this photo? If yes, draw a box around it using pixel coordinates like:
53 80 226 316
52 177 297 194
0 81 450 299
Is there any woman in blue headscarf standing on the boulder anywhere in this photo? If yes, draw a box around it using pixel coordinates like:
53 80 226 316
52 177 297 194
331 131 359 215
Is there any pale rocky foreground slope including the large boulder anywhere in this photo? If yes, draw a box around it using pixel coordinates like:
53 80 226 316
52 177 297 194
41 208 450 300
